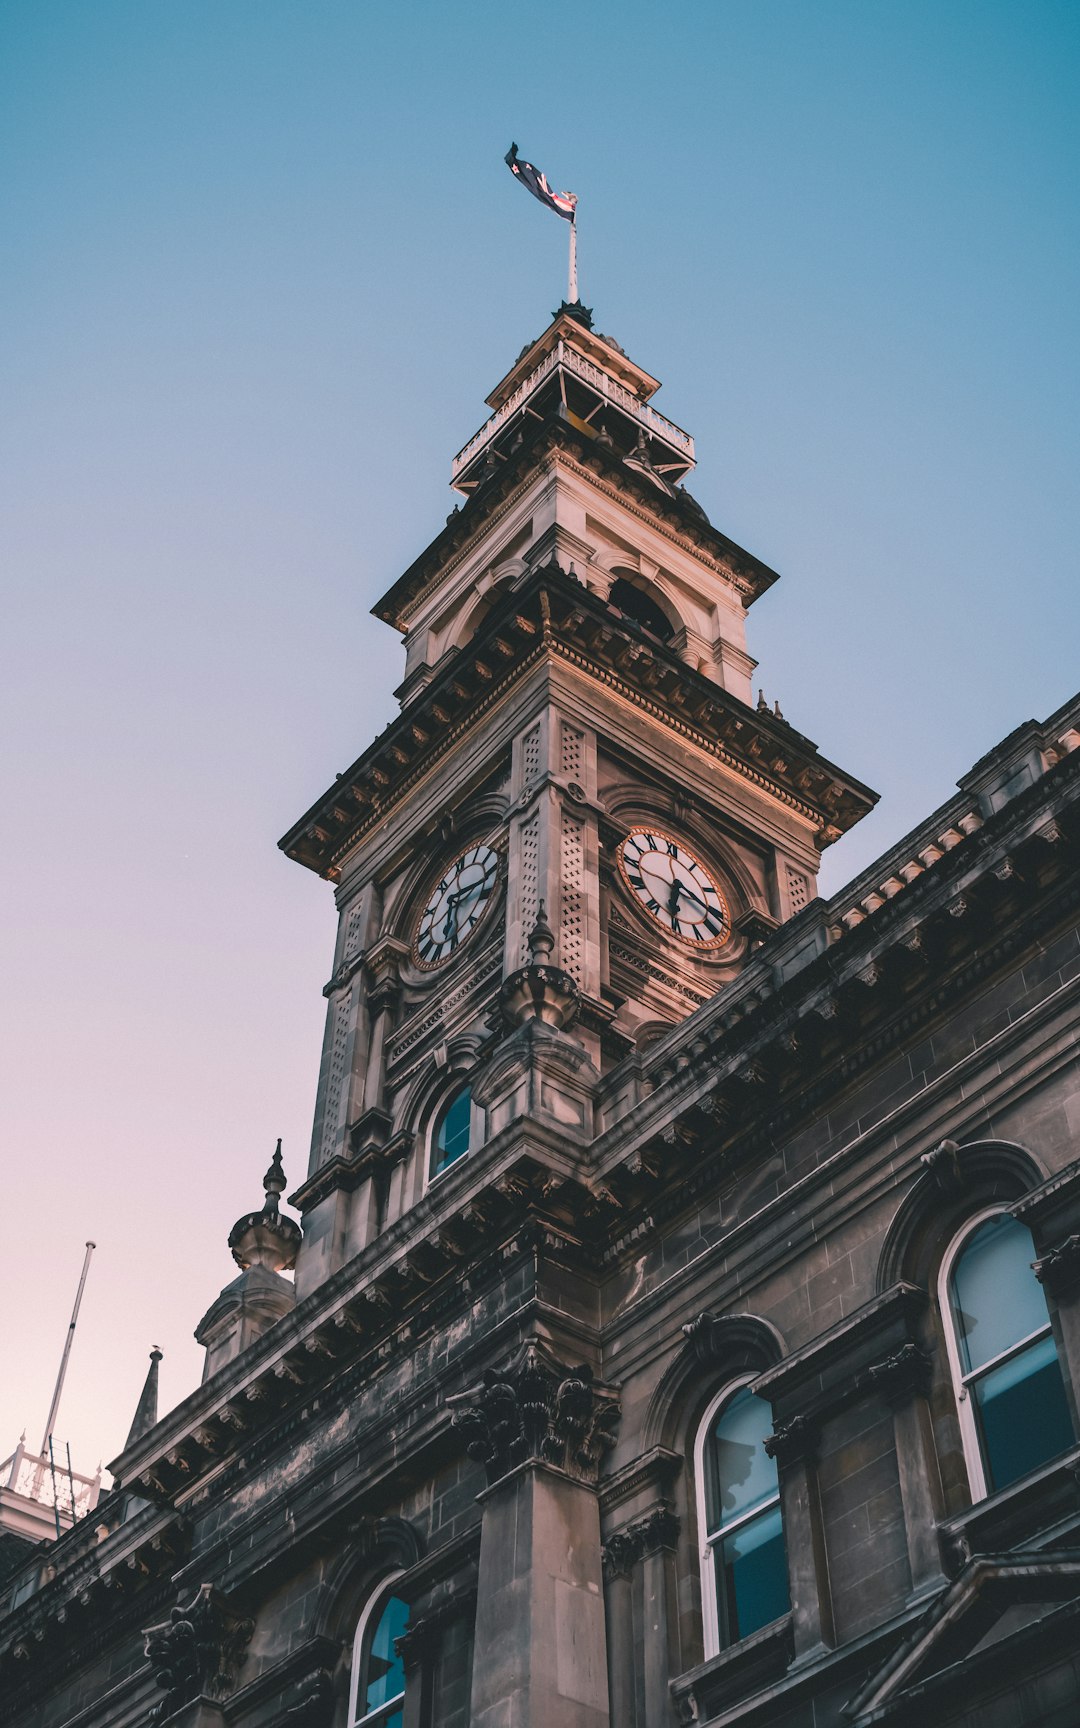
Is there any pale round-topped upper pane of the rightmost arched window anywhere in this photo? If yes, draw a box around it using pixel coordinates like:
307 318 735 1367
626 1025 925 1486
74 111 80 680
952 1215 1049 1374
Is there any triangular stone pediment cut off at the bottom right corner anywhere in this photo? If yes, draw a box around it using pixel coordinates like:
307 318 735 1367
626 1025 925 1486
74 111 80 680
845 1550 1080 1728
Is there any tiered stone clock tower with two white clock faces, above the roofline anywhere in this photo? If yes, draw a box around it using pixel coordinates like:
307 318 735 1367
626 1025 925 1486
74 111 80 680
282 304 874 1296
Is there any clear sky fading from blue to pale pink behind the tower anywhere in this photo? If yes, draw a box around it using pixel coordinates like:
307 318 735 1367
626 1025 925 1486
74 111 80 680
0 0 1080 1472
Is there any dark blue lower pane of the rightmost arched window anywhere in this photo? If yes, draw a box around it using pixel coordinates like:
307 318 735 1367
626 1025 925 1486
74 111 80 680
973 1334 1073 1491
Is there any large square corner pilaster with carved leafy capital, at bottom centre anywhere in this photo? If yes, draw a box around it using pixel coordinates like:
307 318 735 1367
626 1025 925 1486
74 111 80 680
448 1339 617 1728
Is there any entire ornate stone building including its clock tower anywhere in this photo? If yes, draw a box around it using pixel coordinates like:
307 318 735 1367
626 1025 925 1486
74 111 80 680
0 304 1080 1728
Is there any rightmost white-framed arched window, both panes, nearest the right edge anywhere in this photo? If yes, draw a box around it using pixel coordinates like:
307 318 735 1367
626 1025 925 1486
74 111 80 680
940 1211 1073 1500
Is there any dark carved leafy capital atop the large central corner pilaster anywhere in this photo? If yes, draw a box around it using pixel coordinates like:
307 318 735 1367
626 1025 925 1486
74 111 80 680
446 1341 619 1483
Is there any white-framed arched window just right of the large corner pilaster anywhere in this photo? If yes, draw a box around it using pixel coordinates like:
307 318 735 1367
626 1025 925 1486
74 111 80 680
695 1382 791 1655
